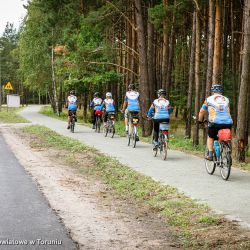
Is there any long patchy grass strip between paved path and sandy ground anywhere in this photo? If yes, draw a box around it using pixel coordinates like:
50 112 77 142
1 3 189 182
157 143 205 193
18 126 250 249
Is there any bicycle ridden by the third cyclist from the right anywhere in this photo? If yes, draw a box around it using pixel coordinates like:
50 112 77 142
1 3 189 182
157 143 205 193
128 111 139 148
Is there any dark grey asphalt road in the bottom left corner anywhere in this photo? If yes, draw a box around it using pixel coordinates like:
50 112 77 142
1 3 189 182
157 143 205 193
0 134 76 250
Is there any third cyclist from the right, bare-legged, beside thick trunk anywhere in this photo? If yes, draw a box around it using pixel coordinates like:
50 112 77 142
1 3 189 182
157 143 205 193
121 83 140 138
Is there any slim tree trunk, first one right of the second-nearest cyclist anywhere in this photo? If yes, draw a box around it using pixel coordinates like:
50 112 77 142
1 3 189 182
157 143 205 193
185 13 196 138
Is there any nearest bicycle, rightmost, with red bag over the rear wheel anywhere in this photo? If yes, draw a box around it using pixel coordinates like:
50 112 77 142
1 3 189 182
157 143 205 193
205 129 232 181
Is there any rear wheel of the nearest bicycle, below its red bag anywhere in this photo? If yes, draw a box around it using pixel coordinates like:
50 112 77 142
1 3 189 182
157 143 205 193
220 143 232 181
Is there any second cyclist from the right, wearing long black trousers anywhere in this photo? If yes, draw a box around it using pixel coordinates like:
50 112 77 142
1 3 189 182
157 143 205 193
147 89 173 149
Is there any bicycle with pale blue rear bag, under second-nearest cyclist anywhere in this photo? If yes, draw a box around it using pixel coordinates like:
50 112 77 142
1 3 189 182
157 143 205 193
152 122 169 161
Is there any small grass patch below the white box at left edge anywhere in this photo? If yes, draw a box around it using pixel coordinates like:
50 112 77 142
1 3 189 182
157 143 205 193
0 107 29 123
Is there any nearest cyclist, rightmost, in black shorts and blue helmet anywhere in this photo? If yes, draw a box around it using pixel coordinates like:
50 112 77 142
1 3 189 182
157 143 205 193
198 84 233 161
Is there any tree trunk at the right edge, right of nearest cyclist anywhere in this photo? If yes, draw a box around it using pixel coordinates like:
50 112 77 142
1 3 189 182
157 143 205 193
236 0 250 162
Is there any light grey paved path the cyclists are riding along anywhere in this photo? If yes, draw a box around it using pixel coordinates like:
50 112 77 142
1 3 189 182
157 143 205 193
20 106 250 228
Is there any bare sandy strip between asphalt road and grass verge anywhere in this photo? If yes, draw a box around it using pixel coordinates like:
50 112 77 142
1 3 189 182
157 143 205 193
1 127 178 250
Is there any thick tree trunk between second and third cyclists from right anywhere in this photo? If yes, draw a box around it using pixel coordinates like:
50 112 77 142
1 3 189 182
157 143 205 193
135 0 152 136
